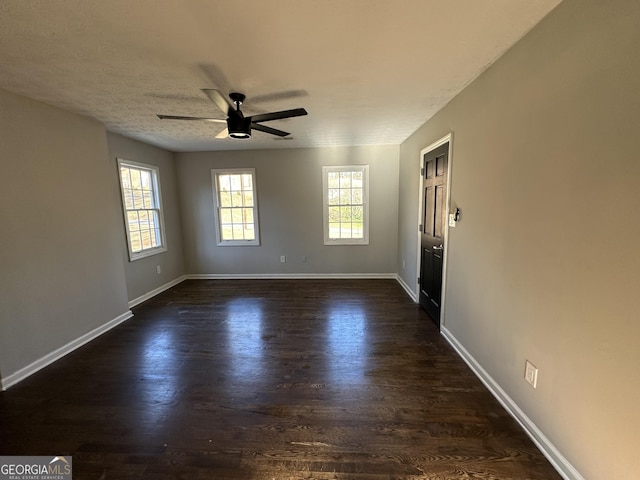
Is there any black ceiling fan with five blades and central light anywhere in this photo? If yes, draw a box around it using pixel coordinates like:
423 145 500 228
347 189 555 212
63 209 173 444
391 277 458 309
158 89 307 138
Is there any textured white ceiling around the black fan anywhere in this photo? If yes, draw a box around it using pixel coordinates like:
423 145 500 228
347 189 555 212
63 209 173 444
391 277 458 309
0 0 560 151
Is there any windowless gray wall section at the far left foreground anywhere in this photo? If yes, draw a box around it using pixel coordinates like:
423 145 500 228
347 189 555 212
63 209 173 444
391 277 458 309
0 90 129 378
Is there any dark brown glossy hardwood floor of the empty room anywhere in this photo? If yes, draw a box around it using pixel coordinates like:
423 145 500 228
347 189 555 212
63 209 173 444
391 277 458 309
0 280 561 480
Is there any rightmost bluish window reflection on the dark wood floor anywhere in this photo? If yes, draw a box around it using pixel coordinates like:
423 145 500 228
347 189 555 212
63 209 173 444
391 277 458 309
327 303 369 384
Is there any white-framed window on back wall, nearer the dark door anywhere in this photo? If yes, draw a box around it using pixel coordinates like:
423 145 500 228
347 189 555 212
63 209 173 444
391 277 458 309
322 165 369 245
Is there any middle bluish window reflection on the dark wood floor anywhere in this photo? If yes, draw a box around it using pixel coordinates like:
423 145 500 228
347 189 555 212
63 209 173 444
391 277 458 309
225 298 264 383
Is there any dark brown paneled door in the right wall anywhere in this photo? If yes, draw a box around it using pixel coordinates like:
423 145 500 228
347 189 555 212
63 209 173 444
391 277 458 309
419 143 449 327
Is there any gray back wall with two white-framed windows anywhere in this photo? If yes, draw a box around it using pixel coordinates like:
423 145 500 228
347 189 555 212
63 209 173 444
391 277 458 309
176 146 399 274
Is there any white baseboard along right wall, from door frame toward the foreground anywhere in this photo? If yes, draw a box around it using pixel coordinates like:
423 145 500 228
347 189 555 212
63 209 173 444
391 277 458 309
440 326 585 480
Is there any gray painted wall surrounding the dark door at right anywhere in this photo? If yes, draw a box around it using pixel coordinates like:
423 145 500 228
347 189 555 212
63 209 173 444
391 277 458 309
398 0 640 480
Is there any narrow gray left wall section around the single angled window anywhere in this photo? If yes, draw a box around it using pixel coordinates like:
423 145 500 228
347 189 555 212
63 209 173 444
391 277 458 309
107 133 185 301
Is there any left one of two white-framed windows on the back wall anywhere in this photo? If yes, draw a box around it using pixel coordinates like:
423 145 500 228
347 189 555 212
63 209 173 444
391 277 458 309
211 168 260 245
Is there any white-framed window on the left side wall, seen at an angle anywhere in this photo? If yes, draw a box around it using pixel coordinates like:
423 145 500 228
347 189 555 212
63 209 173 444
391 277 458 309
118 159 167 260
